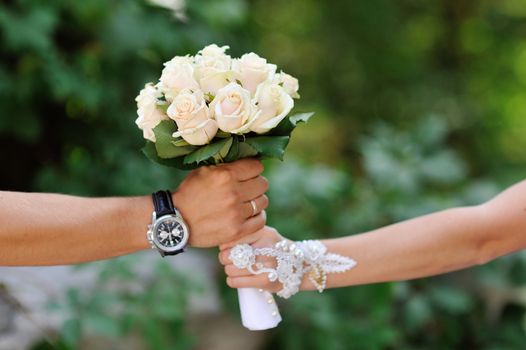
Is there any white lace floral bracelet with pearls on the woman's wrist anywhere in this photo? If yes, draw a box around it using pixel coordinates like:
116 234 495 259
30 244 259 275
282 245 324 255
230 240 357 299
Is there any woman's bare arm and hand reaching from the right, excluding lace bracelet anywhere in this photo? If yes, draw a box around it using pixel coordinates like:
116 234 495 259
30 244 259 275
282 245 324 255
220 181 526 291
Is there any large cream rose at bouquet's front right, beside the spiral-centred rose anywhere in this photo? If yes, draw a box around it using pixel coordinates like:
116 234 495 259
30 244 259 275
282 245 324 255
250 82 294 134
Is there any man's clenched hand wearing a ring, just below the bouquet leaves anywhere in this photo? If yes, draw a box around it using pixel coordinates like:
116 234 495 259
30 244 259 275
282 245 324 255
173 159 268 248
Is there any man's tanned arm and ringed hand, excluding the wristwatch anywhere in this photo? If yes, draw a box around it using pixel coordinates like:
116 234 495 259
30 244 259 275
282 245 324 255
0 160 268 266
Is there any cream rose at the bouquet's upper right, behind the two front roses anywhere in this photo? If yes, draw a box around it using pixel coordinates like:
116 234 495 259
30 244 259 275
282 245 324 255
232 52 276 94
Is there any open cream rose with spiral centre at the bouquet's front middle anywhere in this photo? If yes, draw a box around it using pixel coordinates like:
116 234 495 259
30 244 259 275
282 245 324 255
210 83 255 134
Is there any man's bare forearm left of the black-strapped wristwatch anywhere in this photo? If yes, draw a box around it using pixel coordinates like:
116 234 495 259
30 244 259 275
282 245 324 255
0 192 152 266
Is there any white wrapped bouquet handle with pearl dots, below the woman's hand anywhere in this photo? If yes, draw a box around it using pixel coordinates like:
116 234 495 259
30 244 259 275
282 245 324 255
237 288 281 331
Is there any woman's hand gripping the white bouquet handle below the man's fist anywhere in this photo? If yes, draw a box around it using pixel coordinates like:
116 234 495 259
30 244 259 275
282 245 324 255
219 226 290 293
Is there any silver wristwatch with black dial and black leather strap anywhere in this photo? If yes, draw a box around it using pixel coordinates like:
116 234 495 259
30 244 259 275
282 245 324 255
147 190 190 257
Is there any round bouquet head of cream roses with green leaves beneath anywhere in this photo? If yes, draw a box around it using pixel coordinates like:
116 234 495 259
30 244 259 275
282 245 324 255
136 44 312 169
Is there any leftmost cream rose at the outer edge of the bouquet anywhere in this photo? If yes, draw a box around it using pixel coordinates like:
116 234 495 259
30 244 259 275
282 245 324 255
135 84 168 142
